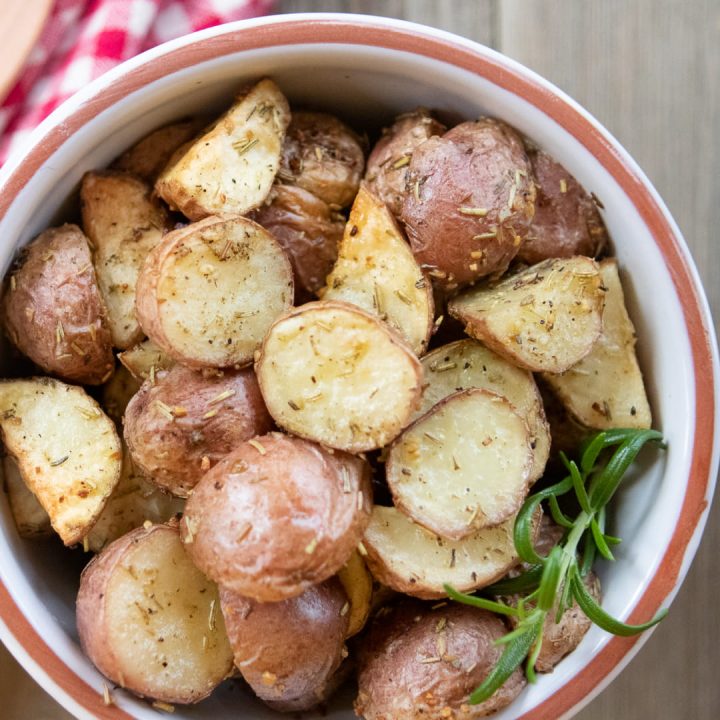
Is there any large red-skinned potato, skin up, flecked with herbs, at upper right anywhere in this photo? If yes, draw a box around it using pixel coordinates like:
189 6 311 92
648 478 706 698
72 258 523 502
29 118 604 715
400 118 535 290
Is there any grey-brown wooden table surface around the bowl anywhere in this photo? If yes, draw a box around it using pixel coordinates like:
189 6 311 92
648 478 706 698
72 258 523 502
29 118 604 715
0 0 720 720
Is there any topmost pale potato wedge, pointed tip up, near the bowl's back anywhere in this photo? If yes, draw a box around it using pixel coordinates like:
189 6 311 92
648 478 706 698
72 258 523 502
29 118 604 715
155 79 290 220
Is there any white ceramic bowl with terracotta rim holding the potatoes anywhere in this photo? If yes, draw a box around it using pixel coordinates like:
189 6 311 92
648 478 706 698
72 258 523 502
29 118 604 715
0 14 719 720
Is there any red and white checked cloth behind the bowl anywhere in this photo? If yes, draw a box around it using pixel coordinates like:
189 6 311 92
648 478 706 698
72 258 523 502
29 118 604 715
0 0 273 166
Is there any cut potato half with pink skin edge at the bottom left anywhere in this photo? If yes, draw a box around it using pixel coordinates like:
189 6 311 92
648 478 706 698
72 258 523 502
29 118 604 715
77 525 232 703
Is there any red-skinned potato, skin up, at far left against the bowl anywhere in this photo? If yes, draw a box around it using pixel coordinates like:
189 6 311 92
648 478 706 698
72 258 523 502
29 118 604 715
3 225 114 385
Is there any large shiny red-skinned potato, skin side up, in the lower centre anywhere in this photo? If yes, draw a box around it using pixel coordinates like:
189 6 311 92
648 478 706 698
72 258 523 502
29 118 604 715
181 433 372 602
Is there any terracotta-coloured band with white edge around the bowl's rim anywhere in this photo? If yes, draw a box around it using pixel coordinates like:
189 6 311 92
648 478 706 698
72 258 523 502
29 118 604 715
0 14 717 720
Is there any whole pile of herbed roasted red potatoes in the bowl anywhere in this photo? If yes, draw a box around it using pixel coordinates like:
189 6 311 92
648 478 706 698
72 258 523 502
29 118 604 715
0 79 650 720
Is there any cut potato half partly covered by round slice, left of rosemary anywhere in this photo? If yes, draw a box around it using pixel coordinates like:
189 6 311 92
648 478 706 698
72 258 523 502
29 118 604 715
363 505 539 600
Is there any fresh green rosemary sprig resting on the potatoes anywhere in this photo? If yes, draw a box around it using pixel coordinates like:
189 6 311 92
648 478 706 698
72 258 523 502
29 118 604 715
445 428 667 704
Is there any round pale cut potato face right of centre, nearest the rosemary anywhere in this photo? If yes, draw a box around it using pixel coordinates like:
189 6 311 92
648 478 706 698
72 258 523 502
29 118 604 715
387 388 533 540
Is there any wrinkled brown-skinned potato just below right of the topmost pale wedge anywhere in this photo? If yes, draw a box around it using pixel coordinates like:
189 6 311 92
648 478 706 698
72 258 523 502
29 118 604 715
250 185 345 303
